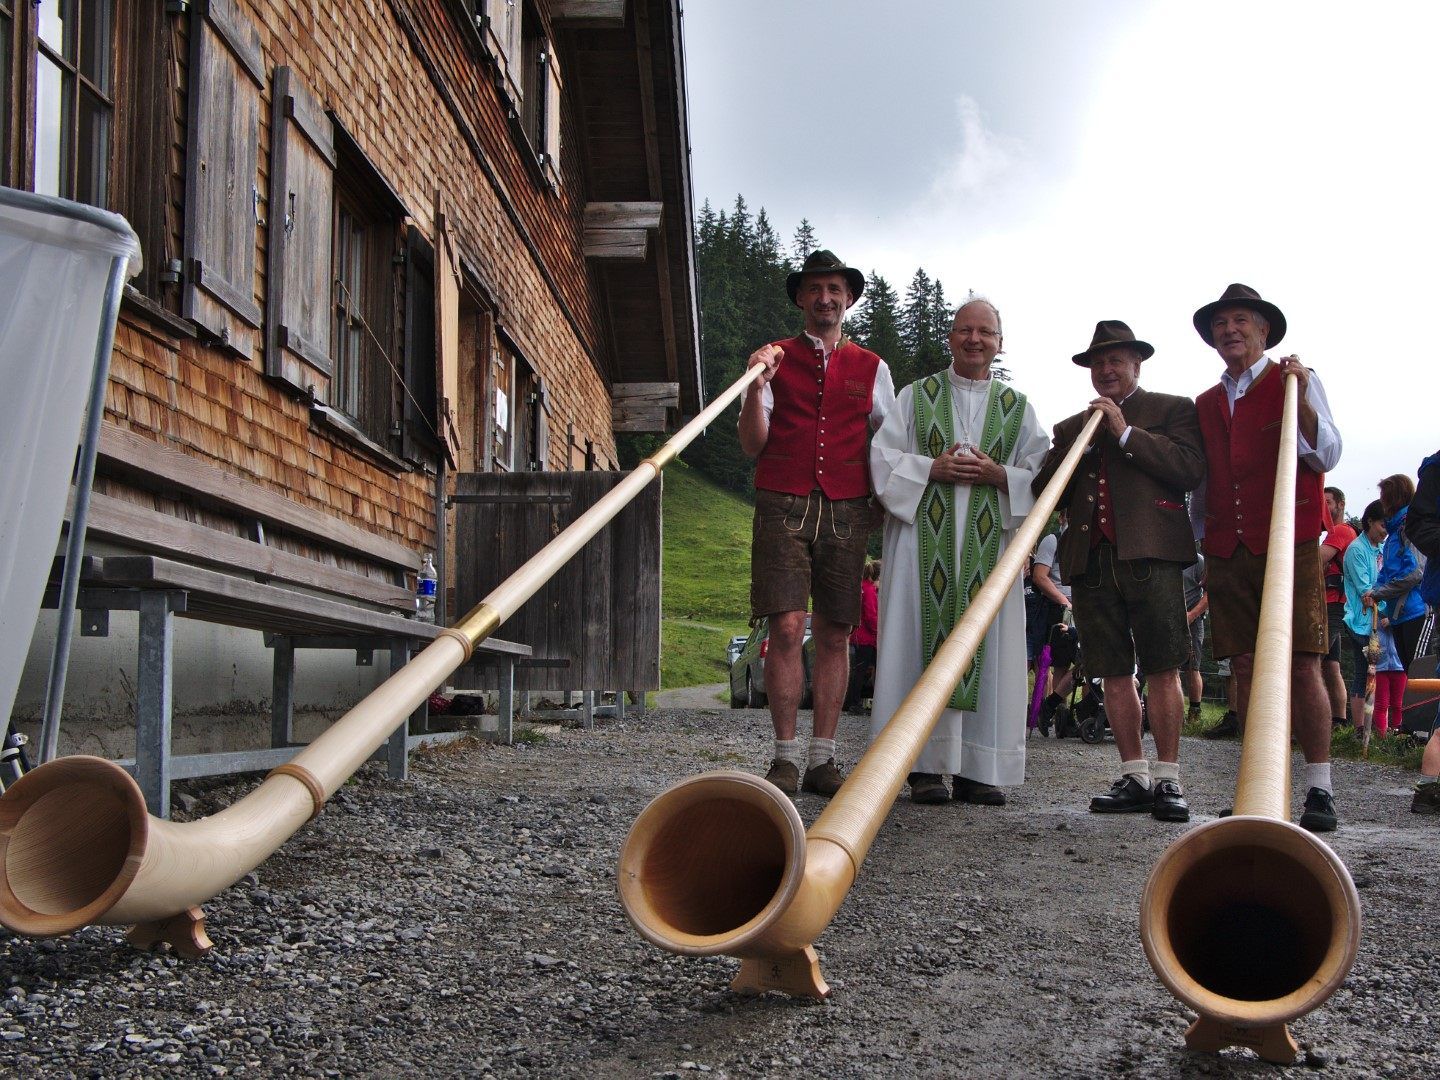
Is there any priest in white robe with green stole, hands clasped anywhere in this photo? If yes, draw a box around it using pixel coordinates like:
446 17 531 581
870 298 1050 805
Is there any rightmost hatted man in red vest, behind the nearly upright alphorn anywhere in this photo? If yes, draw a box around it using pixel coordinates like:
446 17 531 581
1189 285 1341 832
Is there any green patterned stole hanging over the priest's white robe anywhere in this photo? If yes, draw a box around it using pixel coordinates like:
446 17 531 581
914 372 1025 711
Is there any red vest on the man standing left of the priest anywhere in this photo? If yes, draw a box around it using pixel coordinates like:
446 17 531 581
755 336 880 498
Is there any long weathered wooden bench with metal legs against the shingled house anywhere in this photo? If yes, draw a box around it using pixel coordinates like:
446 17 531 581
48 425 531 816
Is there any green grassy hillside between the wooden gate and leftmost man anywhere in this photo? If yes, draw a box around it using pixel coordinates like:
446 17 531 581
660 461 752 688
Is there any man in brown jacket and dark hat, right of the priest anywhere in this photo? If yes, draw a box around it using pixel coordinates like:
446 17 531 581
1031 318 1205 821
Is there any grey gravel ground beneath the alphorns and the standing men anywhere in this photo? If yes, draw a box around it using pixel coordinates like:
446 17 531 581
0 710 1440 1079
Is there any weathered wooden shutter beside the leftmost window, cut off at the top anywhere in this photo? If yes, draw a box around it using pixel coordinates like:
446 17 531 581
183 0 265 359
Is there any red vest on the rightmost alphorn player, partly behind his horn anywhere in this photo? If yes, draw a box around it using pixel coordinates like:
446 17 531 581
1195 363 1325 559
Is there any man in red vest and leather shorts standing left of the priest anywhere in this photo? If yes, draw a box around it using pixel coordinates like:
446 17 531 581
740 251 894 796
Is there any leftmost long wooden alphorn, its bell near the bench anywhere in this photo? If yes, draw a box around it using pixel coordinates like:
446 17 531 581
0 366 777 953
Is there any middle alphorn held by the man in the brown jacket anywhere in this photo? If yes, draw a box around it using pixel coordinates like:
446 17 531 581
618 412 1100 998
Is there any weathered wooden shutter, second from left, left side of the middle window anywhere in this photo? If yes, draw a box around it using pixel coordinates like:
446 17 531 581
265 68 336 402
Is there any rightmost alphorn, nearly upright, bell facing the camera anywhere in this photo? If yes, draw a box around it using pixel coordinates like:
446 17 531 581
1140 376 1361 1063
